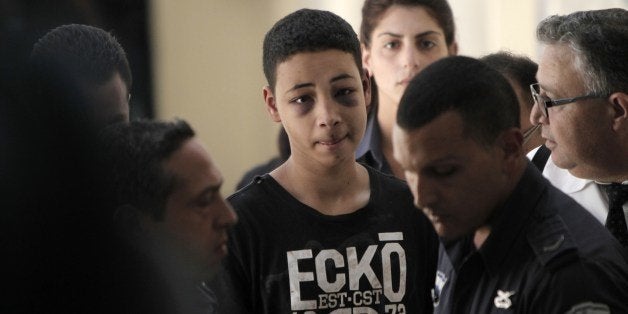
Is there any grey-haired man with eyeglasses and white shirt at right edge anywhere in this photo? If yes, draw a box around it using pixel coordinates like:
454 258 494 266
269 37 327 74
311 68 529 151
528 9 628 247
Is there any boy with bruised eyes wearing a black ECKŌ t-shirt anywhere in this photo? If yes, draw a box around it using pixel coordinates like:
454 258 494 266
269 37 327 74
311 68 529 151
215 9 438 313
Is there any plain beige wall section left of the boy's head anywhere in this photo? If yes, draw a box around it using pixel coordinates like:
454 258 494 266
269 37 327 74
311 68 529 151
152 0 276 194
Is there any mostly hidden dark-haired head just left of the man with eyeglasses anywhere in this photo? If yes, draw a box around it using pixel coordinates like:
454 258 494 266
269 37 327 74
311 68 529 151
480 51 543 153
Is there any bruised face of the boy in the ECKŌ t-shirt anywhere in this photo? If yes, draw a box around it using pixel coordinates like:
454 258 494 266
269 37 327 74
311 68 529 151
264 49 371 166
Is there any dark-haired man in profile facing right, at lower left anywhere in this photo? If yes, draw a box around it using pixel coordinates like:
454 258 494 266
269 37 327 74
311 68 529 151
100 121 236 313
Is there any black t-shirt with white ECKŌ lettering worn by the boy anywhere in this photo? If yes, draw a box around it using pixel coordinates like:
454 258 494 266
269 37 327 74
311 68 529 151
213 167 438 314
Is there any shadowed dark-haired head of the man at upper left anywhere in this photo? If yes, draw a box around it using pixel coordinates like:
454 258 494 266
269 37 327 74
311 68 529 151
31 24 132 128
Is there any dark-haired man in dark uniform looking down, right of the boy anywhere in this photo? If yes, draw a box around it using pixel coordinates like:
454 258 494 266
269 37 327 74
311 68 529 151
393 57 628 313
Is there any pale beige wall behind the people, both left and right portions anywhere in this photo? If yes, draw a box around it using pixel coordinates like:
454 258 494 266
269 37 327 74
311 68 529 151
151 0 628 194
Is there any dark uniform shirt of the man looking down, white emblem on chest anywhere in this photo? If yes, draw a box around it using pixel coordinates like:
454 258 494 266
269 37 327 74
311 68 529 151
434 164 628 313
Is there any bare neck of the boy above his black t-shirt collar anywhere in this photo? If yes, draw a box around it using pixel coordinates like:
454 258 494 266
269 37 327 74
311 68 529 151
270 156 371 216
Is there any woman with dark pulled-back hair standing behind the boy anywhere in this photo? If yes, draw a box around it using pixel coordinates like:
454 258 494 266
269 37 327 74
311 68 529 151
356 0 458 179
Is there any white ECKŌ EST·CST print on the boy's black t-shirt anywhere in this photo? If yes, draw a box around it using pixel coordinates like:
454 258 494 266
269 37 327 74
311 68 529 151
286 232 407 314
